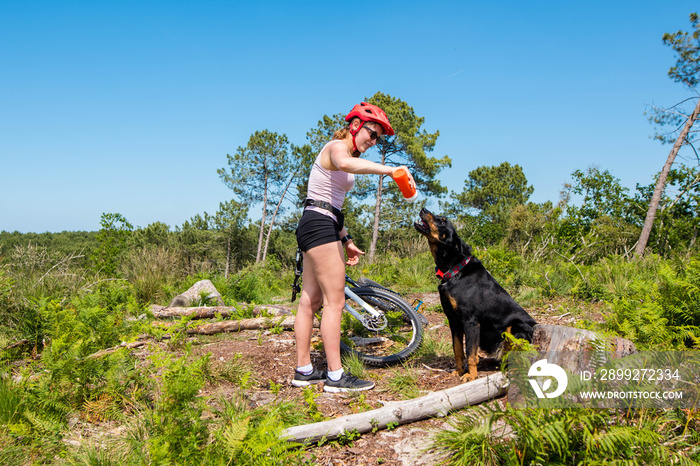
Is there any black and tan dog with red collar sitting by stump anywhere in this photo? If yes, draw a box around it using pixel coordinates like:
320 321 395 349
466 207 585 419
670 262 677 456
414 209 536 382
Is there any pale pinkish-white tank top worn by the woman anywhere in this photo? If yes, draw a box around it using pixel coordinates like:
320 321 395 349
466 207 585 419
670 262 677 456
306 139 355 221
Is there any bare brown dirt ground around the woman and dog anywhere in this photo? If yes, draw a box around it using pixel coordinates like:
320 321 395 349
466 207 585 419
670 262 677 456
165 293 592 465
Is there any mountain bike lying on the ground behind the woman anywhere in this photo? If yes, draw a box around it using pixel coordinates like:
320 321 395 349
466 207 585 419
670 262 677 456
292 249 423 366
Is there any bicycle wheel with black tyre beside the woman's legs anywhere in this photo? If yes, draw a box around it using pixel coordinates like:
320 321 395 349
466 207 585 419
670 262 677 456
340 287 423 366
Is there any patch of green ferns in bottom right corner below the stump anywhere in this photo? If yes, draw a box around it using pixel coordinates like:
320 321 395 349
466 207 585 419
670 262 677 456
434 403 700 466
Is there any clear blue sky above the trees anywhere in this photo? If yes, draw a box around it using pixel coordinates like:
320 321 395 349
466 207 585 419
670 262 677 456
0 0 700 232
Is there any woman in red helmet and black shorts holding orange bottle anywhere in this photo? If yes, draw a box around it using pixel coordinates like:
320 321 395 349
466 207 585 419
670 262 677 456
292 102 412 393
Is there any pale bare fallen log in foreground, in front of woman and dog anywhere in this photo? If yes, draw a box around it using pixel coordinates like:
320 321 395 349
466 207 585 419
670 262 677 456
281 372 506 443
